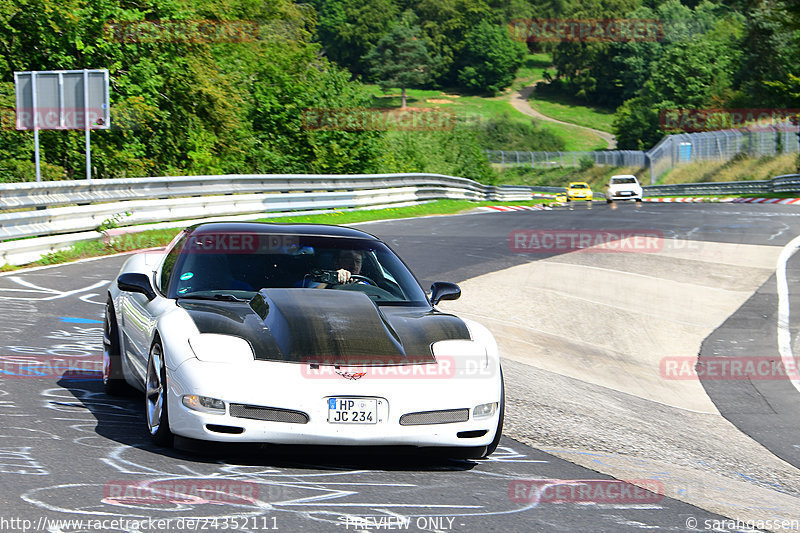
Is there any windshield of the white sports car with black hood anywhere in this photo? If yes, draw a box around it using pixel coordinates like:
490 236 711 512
164 233 427 305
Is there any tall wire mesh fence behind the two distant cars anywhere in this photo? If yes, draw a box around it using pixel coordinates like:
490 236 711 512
486 127 800 184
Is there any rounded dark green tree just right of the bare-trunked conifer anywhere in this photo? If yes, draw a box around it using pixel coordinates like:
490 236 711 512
458 20 527 95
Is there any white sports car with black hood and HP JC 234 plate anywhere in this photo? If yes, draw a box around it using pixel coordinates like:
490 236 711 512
103 223 504 457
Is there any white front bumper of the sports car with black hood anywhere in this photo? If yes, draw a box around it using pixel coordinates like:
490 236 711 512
167 359 501 447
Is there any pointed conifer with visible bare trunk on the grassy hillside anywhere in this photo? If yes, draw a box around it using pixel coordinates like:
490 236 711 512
363 11 433 107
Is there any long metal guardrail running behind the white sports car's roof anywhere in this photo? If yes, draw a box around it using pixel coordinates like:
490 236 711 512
0 174 532 264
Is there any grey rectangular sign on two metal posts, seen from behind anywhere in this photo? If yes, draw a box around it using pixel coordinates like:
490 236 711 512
14 69 111 181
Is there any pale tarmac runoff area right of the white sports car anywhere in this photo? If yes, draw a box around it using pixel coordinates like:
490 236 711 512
439 240 800 531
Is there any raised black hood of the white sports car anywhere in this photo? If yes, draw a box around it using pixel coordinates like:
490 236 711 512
179 288 470 366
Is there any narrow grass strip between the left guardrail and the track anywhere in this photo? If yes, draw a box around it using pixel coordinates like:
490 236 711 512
0 199 548 272
